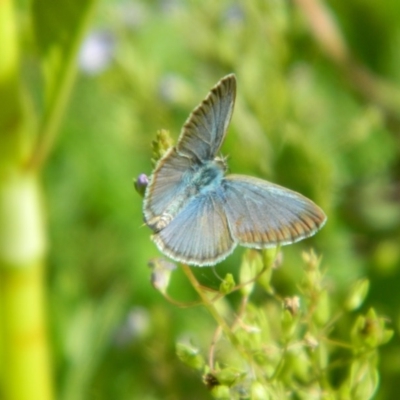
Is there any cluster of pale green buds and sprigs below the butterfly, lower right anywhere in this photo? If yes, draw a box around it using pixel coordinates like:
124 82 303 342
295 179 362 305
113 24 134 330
170 251 393 400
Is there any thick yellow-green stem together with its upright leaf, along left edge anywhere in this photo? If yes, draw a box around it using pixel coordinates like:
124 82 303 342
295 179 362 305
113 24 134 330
0 0 94 400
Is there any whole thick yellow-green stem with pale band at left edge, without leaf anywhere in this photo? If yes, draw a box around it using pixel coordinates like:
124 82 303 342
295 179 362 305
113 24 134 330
0 0 52 400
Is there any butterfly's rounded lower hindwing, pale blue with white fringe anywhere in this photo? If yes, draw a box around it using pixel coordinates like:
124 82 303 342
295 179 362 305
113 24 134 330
153 190 235 266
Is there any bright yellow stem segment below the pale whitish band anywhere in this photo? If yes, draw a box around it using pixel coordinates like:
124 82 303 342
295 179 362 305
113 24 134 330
0 262 53 400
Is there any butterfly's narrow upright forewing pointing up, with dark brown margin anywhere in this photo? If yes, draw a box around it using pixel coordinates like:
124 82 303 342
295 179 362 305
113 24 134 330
176 74 236 162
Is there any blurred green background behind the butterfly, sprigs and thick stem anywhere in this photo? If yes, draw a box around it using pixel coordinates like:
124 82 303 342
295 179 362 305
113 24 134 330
0 0 400 400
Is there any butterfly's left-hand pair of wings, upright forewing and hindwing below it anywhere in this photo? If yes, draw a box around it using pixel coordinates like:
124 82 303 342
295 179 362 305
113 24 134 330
144 74 236 223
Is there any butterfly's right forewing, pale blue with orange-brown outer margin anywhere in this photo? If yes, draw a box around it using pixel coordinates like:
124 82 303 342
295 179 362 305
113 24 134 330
222 175 326 248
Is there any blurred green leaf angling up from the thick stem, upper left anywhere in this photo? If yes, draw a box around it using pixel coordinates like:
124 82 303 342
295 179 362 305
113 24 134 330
29 0 96 167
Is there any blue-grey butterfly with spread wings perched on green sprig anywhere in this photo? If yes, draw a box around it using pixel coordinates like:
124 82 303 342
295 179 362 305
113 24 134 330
143 74 326 266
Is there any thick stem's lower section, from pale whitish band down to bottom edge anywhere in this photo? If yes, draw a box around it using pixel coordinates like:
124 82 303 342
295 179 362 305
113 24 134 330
0 173 52 400
